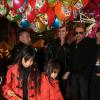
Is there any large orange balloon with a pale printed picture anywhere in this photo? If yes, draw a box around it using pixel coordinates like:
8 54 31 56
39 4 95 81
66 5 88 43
55 1 71 21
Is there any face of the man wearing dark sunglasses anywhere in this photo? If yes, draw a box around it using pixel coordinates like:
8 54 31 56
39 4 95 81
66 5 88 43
75 27 85 41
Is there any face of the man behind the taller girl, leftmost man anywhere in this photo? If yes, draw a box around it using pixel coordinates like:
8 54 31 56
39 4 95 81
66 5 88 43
20 32 31 45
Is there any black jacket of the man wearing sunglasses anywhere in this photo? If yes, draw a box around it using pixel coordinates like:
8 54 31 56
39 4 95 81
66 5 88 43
70 38 96 75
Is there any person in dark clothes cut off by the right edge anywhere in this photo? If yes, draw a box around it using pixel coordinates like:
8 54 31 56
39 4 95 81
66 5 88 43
90 28 100 100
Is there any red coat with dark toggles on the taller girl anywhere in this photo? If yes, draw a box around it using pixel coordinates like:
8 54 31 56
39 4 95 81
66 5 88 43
2 64 38 100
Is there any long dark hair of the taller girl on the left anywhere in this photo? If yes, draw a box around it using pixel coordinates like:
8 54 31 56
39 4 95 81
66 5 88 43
15 46 40 92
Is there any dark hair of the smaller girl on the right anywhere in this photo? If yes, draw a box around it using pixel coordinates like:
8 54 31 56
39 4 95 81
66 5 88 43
44 59 60 81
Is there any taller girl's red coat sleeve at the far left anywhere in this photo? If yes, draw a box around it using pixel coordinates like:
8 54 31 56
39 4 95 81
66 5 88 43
2 69 11 98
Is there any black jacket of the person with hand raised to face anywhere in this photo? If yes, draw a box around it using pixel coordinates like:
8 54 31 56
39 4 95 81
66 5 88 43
46 38 69 73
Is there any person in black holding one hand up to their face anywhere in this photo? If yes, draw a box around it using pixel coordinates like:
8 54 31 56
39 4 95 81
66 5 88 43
46 24 69 100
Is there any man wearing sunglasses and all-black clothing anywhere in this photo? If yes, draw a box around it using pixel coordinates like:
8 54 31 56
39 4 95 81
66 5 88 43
70 23 96 100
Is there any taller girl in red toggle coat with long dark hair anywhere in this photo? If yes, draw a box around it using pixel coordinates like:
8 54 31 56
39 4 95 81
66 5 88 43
3 46 39 100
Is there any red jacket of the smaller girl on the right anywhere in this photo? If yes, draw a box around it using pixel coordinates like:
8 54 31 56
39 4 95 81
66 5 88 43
39 73 64 100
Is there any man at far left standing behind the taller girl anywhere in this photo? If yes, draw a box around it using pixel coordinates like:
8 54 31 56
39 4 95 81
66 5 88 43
10 30 31 64
